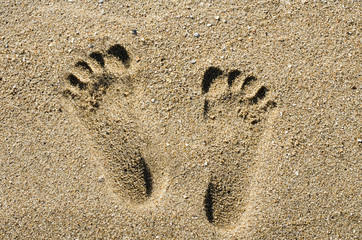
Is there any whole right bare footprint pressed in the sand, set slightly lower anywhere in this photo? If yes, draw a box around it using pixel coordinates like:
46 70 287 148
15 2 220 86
201 67 276 228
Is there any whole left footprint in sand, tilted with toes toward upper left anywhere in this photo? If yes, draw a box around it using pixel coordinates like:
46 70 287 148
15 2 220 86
63 44 157 204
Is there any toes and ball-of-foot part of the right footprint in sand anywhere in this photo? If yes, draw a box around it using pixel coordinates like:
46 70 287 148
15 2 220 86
202 67 276 124
